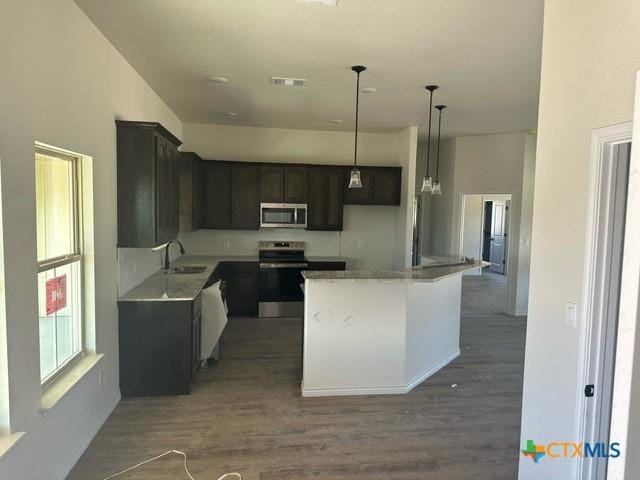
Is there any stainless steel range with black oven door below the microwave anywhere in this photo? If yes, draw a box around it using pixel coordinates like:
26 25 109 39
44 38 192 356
258 241 307 317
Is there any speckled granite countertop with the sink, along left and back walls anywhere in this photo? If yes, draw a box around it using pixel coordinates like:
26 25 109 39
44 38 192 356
118 255 258 302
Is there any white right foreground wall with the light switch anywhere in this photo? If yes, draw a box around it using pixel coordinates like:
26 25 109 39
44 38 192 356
519 0 640 480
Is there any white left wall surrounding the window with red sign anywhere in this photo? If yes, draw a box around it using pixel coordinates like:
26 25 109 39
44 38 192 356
0 0 182 480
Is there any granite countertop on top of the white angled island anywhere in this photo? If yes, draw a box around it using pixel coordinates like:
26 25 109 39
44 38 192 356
302 261 489 283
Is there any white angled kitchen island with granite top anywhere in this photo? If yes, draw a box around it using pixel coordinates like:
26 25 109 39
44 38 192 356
302 258 486 397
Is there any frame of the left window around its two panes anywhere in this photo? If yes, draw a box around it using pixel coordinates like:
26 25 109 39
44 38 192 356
34 144 86 389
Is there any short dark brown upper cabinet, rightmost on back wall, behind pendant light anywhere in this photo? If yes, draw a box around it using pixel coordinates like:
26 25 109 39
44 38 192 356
344 167 402 205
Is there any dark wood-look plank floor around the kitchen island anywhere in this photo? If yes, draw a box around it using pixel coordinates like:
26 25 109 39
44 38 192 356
69 277 525 480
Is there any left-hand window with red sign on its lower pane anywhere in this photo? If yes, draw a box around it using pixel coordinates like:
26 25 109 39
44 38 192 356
36 147 83 384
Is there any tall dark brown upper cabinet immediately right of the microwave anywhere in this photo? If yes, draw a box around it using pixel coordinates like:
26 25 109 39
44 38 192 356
307 166 344 231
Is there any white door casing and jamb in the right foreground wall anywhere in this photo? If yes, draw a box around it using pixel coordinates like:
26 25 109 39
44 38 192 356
578 129 631 480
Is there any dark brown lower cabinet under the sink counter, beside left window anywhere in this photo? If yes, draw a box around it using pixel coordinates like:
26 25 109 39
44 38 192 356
118 297 201 397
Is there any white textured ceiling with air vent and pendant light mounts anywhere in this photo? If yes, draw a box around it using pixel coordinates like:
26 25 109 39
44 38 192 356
76 0 543 136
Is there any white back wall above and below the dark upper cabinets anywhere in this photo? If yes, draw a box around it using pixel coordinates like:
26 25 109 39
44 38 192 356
180 123 417 269
